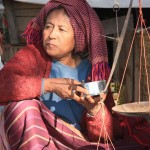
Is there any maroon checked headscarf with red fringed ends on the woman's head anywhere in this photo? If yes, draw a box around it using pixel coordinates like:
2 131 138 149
23 0 110 81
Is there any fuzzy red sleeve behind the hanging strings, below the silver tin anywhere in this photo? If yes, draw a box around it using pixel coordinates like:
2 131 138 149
85 104 113 142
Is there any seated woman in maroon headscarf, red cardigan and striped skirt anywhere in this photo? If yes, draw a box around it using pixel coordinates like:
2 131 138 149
0 0 150 150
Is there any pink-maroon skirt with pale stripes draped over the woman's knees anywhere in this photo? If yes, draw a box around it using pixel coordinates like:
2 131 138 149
4 99 145 150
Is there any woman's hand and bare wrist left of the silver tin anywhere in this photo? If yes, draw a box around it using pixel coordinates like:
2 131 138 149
44 78 89 103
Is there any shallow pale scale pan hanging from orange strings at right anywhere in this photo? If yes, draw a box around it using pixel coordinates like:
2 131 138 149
112 101 150 118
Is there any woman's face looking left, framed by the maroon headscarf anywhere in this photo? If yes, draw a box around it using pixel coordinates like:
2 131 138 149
43 9 75 60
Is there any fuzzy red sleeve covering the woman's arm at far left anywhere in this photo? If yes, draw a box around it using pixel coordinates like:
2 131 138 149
0 46 46 104
